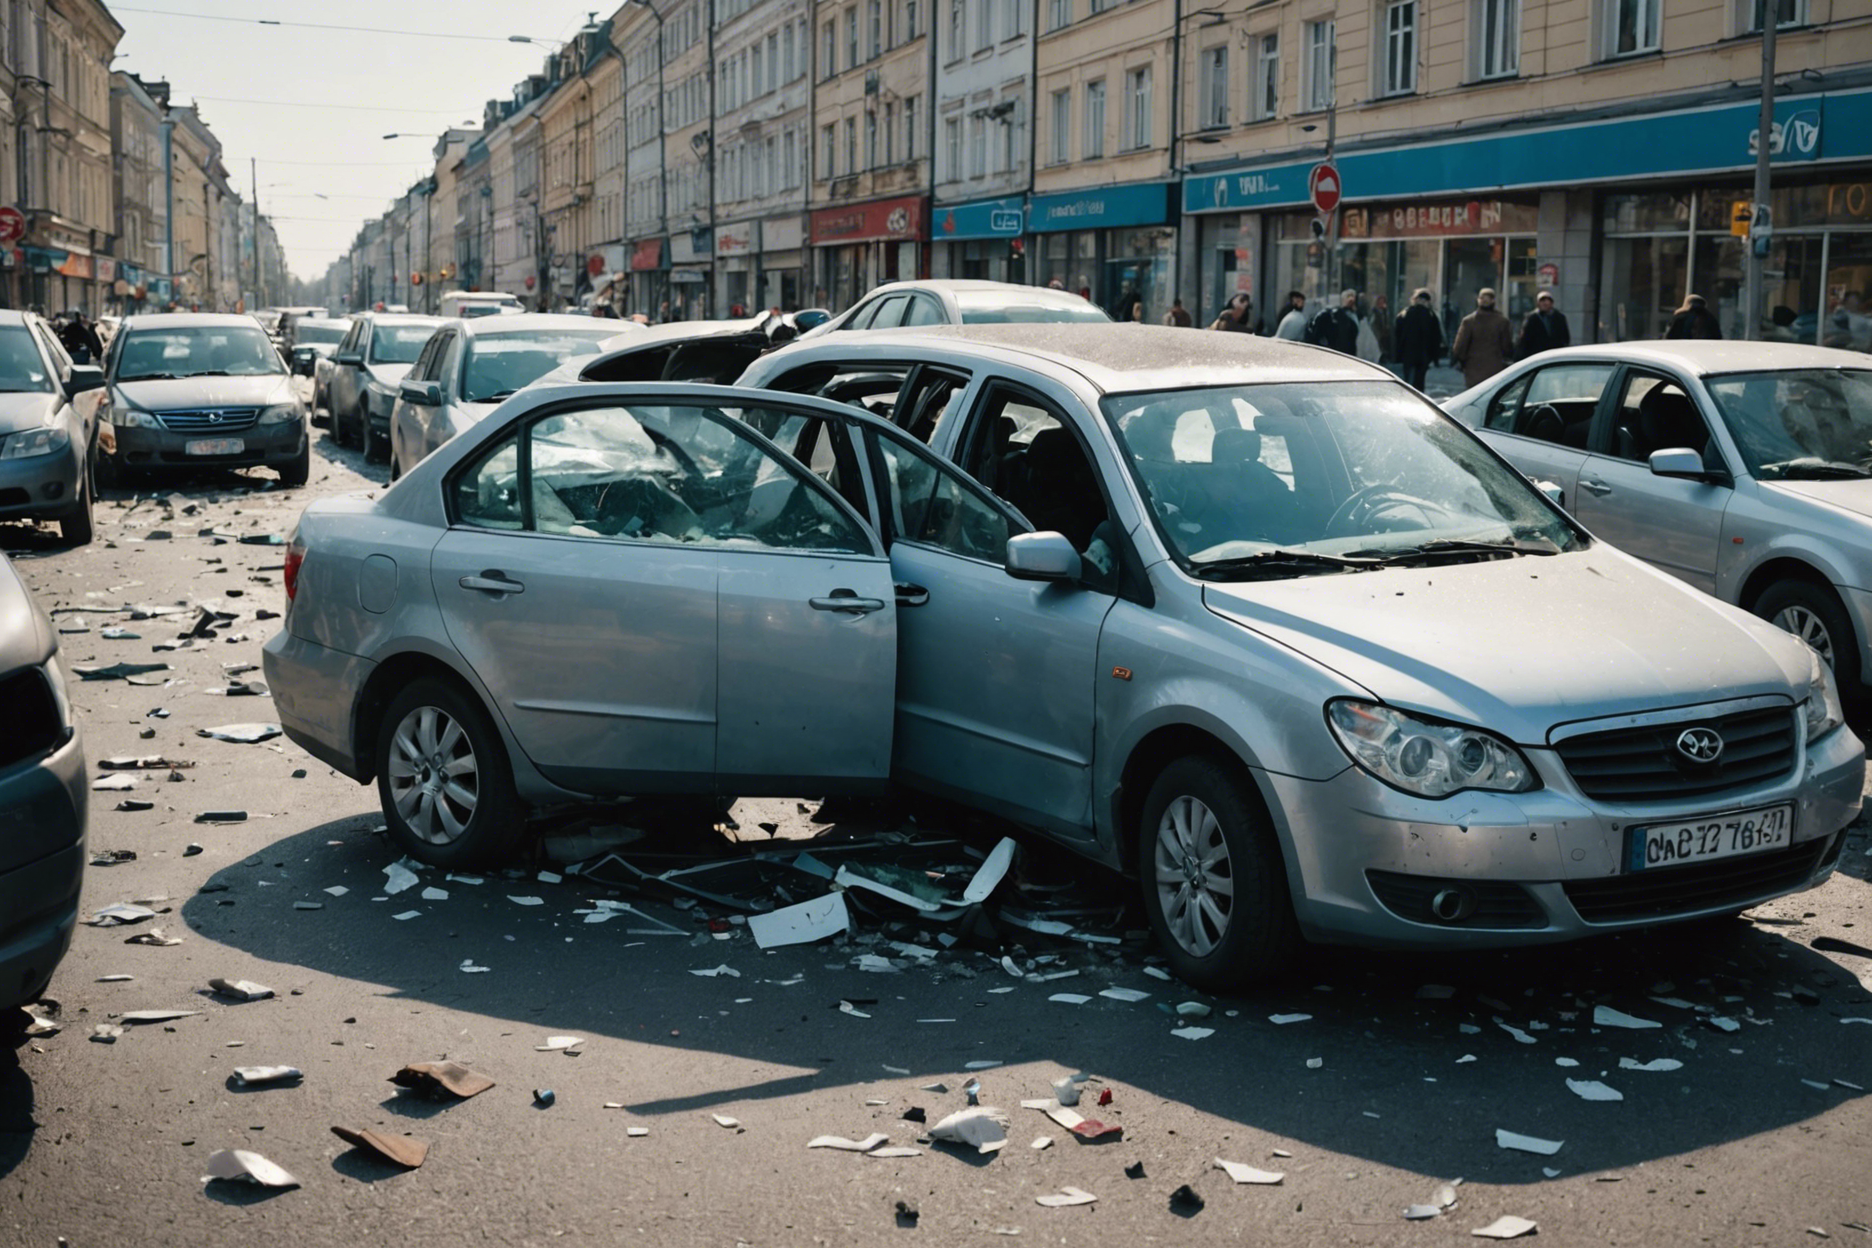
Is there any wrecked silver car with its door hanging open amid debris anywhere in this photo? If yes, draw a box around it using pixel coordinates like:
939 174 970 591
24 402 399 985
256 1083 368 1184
266 326 1865 986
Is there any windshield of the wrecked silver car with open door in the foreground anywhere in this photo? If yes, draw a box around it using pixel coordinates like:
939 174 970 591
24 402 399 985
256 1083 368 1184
1104 382 1582 578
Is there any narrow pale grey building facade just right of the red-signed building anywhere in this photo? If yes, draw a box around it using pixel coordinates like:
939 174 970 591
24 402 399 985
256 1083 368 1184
930 0 1033 283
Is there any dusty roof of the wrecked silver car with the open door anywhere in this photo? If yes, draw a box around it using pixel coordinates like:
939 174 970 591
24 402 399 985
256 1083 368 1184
771 322 1397 393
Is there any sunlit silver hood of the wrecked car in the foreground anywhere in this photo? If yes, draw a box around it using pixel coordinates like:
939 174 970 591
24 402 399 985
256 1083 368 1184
1204 544 1812 745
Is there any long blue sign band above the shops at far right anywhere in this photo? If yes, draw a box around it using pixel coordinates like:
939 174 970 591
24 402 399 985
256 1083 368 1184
1190 92 1872 215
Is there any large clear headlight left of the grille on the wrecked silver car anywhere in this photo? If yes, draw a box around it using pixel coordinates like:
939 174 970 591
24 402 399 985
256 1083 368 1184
1325 698 1541 797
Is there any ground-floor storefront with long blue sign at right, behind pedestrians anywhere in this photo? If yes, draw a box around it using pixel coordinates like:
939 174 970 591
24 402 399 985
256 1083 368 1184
1183 88 1872 346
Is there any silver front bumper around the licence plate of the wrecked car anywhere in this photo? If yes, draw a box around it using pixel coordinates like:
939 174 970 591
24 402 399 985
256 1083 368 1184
1260 711 1865 949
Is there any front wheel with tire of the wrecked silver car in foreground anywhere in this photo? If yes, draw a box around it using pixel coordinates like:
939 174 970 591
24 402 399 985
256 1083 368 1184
1138 756 1301 992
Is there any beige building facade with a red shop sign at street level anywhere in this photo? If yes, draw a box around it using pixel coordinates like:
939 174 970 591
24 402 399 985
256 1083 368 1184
807 0 936 307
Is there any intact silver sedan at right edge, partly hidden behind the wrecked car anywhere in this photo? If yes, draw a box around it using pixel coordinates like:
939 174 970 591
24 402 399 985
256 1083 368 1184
1443 341 1872 696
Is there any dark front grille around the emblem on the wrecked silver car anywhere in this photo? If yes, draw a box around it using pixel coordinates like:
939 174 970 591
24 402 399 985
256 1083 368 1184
1554 709 1797 801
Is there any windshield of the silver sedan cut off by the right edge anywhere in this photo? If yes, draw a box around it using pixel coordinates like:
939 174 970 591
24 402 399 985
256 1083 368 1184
1704 369 1872 481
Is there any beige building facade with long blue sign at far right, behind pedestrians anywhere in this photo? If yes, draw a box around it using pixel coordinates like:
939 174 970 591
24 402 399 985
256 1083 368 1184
1181 0 1872 348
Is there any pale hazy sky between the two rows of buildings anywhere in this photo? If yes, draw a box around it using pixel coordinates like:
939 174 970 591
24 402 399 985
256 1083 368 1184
105 0 618 279
